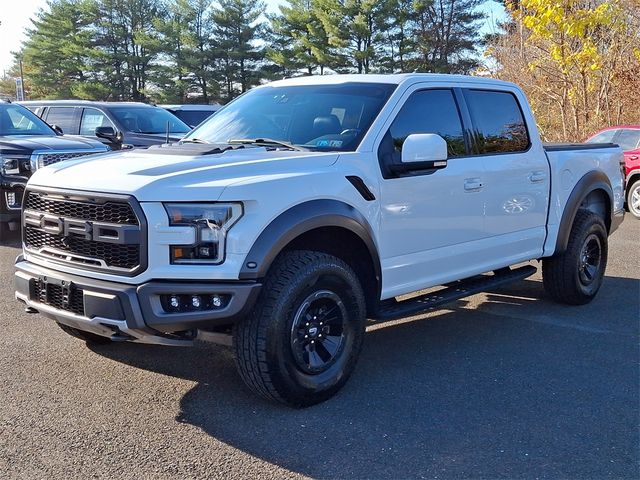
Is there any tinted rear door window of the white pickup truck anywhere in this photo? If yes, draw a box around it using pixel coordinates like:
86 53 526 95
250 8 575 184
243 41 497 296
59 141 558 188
464 90 530 155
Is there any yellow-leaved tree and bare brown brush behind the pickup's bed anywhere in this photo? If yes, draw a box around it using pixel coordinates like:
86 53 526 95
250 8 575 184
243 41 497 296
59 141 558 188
488 0 640 140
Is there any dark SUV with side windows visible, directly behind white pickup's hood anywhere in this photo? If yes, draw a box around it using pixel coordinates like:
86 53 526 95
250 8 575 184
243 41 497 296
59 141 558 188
20 100 190 150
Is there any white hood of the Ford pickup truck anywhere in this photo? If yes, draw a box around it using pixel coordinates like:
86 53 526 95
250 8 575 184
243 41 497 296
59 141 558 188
29 145 338 202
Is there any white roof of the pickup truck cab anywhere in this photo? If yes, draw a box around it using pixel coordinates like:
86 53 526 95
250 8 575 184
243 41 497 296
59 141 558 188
267 73 513 86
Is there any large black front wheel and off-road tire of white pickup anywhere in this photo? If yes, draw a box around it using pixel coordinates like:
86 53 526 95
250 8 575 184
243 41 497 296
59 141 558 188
233 250 366 408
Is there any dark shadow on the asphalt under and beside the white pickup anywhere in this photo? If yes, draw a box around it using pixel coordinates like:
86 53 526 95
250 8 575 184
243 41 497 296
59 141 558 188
93 277 640 478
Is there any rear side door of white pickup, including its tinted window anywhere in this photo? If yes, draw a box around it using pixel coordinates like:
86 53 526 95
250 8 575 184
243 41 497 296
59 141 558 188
463 89 550 266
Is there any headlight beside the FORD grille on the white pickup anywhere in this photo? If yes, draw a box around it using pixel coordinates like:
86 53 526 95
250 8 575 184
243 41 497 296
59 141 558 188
164 203 242 264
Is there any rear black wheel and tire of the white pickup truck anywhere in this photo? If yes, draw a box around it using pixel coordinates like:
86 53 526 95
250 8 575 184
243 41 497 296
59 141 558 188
542 210 608 305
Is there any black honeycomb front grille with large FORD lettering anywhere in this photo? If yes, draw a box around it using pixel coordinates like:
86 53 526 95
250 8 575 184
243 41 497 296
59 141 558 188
23 190 146 275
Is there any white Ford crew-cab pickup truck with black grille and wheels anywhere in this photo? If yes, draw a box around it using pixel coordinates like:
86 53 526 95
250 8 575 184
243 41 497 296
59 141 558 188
15 74 624 406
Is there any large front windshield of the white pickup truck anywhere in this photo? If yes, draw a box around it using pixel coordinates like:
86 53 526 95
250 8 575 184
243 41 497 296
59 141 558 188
185 83 396 151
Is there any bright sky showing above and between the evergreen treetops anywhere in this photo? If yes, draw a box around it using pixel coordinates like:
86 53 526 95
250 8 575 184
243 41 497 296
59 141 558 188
0 0 504 75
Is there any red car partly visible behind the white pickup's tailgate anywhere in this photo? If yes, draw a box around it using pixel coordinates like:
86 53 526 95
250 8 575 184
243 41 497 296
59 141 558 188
587 125 640 220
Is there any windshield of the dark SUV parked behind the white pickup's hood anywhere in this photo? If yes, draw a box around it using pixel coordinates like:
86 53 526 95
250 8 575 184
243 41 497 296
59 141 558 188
109 106 191 134
